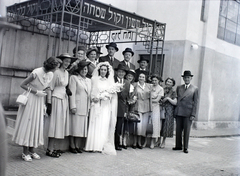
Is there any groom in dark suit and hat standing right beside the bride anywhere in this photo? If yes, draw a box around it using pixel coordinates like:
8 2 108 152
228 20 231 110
115 64 130 150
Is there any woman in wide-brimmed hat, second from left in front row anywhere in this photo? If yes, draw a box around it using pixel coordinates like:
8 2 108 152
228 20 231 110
46 53 74 157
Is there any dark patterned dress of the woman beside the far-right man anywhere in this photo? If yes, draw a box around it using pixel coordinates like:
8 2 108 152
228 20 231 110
161 87 177 137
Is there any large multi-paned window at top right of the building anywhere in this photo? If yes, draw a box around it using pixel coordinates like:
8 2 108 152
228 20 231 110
217 0 240 46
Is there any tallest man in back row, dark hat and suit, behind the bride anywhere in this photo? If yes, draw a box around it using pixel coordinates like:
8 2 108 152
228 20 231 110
99 42 120 69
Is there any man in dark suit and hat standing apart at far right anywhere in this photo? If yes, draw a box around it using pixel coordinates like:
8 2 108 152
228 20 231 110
173 70 198 153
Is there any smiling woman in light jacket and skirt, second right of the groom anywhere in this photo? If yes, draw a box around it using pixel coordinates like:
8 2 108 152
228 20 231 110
131 73 152 149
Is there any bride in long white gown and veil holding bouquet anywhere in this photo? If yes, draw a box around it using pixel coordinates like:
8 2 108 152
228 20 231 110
85 62 117 155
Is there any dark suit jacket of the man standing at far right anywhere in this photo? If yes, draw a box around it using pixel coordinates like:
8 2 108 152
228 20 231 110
175 84 198 117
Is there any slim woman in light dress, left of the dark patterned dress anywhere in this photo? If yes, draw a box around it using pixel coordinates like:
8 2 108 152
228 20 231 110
150 74 164 149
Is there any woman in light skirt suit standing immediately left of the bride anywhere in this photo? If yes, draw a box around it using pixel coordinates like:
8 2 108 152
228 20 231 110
69 61 91 153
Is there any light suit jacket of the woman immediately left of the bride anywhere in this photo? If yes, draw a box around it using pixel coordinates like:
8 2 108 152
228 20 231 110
69 75 91 116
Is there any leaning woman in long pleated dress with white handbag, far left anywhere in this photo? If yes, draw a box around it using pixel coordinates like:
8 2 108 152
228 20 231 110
13 57 58 161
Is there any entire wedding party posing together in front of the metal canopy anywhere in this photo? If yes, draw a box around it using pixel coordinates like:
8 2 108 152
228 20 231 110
13 42 198 161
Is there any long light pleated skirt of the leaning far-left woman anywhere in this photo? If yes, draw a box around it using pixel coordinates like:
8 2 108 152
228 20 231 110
12 93 45 148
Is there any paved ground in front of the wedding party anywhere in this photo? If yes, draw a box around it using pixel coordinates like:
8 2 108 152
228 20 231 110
7 129 240 176
